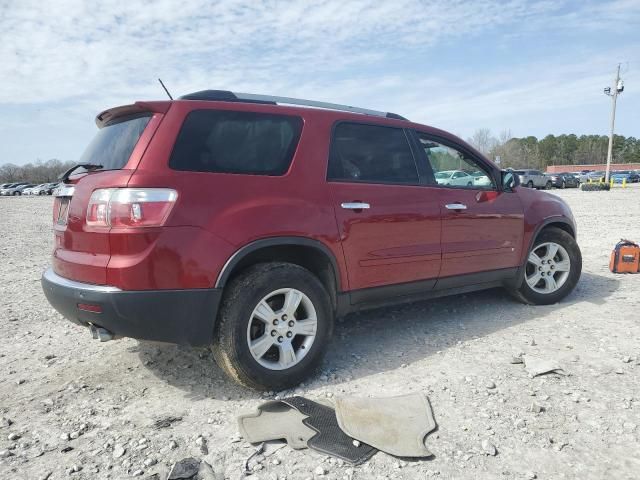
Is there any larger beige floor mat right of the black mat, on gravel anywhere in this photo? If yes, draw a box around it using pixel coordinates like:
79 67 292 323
335 393 436 457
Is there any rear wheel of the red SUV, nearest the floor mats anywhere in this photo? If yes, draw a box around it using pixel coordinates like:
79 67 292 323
212 263 334 391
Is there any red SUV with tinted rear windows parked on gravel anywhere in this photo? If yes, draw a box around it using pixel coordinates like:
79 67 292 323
42 90 582 389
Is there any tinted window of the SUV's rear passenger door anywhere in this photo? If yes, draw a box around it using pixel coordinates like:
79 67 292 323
328 123 419 185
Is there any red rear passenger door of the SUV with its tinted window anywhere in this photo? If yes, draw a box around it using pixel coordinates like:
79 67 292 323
328 122 440 296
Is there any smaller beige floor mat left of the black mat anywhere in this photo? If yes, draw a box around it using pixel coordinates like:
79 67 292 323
238 401 316 449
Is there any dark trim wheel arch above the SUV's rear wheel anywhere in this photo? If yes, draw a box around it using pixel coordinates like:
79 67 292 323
215 237 341 308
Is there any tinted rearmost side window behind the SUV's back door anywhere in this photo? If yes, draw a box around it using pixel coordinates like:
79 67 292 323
169 110 302 175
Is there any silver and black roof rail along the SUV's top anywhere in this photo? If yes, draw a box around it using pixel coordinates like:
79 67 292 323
180 90 407 120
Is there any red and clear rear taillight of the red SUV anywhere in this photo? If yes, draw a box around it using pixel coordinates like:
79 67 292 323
87 188 178 228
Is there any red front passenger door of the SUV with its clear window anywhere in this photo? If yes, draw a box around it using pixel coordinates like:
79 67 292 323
416 132 524 282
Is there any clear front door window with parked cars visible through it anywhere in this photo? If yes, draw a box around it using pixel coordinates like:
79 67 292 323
417 132 496 190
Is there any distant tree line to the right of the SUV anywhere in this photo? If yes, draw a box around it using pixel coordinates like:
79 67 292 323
467 128 640 171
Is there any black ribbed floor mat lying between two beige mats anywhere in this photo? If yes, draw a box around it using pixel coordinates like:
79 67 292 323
282 397 378 465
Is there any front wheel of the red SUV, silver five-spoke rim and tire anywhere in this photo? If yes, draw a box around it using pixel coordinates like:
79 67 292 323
511 227 582 305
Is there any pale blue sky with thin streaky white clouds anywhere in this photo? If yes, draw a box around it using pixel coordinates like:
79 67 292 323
0 0 640 164
